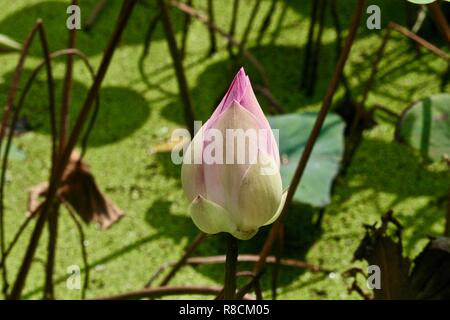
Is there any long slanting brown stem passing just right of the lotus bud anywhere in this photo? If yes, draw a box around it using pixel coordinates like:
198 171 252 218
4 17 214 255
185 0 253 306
241 0 365 294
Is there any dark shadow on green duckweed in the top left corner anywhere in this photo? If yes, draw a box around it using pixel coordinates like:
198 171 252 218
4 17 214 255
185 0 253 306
0 0 183 56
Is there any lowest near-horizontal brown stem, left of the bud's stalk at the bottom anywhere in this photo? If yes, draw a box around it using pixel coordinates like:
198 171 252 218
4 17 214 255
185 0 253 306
95 286 253 300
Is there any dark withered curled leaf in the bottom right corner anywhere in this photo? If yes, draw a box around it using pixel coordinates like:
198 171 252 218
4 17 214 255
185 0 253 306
354 212 450 299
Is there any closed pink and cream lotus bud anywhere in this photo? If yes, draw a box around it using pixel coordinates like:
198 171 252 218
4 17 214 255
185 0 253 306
181 69 286 240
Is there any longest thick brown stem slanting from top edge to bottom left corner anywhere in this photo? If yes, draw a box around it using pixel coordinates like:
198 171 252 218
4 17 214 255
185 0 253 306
9 0 136 299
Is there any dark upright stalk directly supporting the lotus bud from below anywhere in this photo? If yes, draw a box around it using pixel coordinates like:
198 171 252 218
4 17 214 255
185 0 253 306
224 233 238 300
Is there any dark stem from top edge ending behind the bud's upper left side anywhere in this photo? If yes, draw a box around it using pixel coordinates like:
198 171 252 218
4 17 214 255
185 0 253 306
158 0 195 137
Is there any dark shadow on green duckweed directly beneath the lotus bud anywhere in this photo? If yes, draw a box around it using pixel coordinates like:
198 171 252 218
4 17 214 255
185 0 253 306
146 196 321 285
